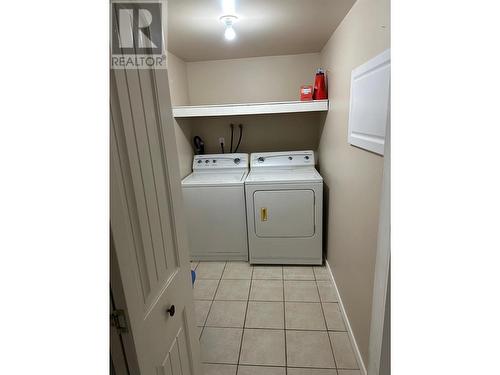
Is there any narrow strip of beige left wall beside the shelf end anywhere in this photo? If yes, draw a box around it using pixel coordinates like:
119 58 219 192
168 52 193 178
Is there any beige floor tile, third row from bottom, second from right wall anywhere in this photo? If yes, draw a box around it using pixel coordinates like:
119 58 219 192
285 302 326 331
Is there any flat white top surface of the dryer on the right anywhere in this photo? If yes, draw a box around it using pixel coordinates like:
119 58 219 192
245 167 323 185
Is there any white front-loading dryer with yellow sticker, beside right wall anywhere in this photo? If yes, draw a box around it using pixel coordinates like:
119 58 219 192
245 151 323 264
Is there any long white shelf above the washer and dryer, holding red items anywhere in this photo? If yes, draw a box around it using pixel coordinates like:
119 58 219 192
172 99 328 118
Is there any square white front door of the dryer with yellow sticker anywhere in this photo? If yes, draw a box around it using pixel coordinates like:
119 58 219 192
254 190 315 237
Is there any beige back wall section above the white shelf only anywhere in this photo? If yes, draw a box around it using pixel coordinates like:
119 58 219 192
187 53 320 105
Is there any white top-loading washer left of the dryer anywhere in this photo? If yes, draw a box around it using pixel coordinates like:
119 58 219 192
182 154 248 261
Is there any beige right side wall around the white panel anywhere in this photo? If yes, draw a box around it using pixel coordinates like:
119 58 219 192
319 0 390 363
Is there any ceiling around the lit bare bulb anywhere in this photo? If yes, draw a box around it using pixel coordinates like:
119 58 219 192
167 0 355 61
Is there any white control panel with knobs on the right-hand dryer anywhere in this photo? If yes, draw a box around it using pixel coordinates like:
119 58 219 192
250 151 315 168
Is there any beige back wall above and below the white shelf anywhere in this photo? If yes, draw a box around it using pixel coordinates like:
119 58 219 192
187 53 320 153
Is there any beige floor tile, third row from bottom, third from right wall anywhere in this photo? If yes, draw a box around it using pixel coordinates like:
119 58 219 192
245 301 285 329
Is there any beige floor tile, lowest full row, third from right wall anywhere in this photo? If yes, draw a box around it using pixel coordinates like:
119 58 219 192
240 328 285 366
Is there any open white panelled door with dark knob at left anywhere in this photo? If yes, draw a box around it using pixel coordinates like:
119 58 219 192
110 58 201 375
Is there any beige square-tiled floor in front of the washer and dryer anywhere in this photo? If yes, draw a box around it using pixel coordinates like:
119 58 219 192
192 262 361 375
